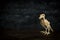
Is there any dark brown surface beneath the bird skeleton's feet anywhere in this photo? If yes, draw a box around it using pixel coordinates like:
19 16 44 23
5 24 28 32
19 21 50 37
0 30 60 40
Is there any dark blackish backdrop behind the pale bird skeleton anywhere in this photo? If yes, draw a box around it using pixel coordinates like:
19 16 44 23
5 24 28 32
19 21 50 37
0 0 60 40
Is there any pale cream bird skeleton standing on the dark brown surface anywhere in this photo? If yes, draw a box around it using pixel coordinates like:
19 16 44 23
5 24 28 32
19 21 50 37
39 14 53 35
